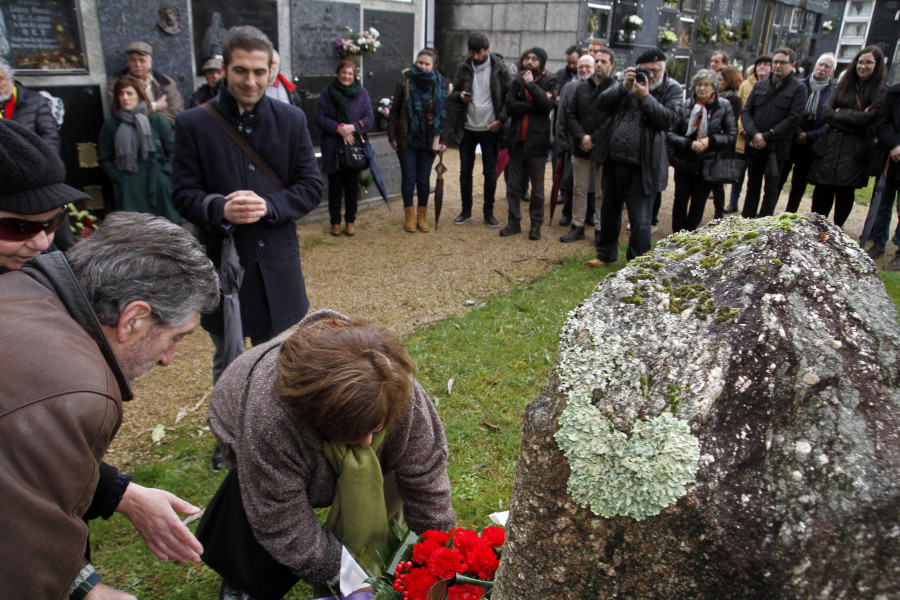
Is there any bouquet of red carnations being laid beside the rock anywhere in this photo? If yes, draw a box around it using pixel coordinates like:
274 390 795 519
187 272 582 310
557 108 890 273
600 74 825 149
369 526 506 600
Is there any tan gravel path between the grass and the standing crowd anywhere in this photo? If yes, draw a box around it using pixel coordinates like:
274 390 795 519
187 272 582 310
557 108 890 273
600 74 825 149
108 150 872 468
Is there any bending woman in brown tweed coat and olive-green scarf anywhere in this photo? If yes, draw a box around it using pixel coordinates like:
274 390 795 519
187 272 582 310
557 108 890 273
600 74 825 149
209 311 456 597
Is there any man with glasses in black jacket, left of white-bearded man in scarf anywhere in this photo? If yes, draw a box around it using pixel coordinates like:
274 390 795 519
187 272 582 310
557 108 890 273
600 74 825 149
741 48 807 219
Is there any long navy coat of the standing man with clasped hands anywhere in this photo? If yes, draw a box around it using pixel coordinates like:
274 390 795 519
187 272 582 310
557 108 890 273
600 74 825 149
172 86 323 337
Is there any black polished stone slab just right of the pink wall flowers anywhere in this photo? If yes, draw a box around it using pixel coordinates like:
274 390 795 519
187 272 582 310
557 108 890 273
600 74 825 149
362 10 414 115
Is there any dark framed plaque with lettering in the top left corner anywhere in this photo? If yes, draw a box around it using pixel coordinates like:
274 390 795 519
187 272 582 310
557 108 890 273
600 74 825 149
0 0 87 74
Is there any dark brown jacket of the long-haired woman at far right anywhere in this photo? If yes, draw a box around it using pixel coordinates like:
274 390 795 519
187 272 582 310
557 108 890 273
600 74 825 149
809 84 884 188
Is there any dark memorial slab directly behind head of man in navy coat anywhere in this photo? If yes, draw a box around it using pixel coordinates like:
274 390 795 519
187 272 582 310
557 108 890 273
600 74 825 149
192 0 278 75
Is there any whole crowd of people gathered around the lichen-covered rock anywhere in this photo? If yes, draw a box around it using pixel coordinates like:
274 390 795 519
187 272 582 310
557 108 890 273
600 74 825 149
0 26 900 600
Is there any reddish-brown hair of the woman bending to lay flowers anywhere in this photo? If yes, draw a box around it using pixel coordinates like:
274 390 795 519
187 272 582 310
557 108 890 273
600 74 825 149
274 317 415 442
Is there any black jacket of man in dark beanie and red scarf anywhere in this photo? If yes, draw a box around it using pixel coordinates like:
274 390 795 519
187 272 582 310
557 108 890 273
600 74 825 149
506 71 556 156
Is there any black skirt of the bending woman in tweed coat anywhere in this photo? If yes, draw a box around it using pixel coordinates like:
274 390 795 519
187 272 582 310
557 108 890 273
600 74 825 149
197 468 300 600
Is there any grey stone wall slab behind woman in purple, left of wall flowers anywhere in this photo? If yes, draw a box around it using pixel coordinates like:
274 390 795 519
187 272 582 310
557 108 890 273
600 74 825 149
291 0 356 76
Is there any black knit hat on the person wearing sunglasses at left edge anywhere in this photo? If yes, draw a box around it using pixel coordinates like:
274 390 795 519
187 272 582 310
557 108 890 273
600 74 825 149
0 119 89 215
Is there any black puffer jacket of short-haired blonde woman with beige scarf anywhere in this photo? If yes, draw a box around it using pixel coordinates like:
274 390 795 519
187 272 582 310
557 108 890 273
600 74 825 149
666 96 737 175
